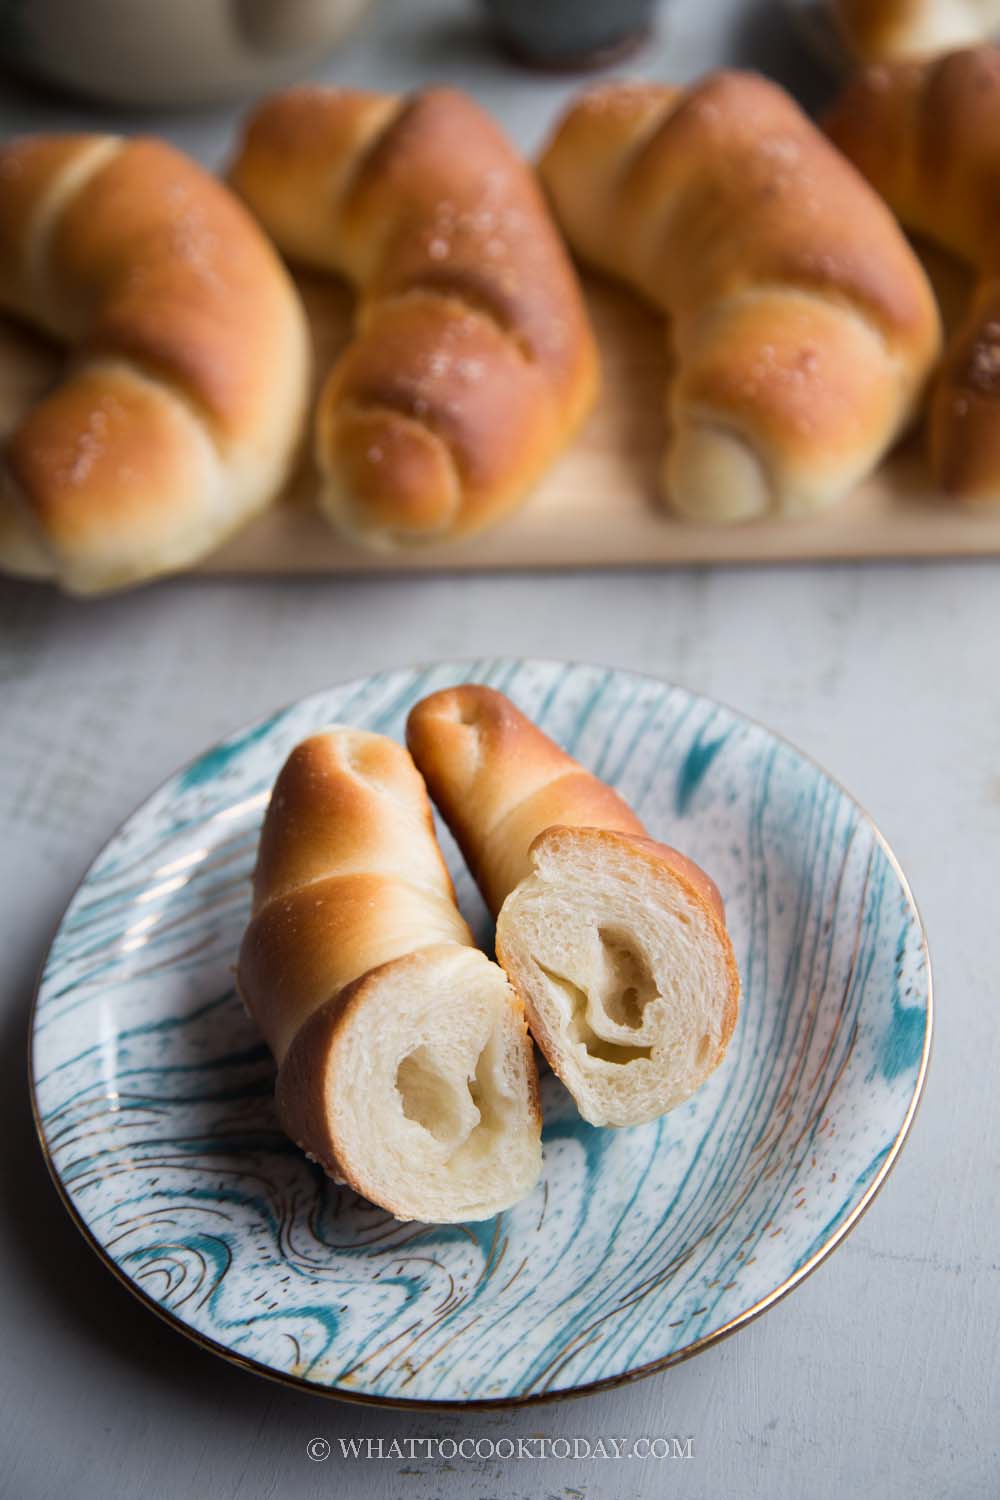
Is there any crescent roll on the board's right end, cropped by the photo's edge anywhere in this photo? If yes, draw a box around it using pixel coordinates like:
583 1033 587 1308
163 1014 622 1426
828 47 1000 506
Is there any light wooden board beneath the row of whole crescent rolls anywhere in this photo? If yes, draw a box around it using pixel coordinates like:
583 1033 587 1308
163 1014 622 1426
0 267 1000 573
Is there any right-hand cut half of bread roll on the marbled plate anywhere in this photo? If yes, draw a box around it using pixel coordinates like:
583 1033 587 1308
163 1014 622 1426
406 686 739 1125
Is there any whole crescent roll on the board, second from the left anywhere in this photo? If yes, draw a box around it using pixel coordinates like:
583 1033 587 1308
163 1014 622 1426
231 89 597 549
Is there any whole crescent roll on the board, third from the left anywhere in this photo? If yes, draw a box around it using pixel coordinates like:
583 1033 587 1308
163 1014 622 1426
540 72 939 521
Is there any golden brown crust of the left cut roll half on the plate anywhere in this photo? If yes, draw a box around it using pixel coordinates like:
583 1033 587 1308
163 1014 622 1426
237 731 472 1064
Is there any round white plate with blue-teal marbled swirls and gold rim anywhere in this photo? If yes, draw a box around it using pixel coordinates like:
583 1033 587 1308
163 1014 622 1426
31 660 931 1406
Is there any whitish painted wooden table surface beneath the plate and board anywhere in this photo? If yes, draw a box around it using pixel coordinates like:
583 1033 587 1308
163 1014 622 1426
0 0 1000 1500
